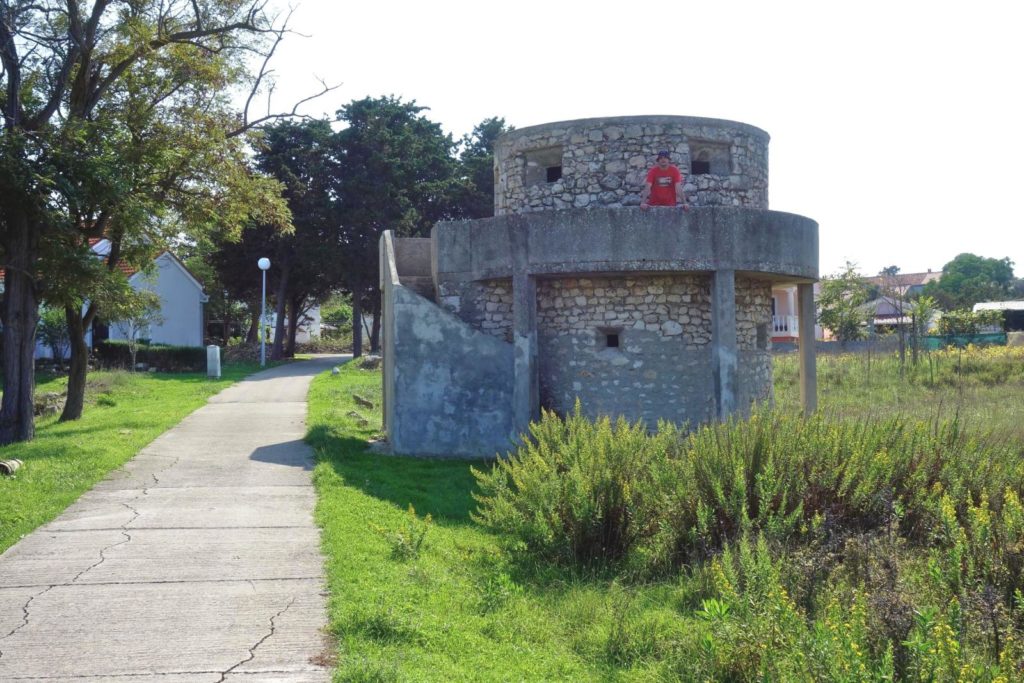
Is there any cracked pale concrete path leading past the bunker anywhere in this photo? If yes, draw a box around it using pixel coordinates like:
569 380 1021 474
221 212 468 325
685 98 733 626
0 356 342 683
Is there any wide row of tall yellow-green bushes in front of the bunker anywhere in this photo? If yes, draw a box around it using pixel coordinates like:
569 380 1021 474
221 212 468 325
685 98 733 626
474 408 1024 575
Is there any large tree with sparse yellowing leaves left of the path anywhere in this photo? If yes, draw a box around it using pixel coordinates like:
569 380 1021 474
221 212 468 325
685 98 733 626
0 0 319 443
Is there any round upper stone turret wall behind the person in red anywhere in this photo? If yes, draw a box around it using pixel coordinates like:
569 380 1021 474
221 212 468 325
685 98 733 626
495 117 768 215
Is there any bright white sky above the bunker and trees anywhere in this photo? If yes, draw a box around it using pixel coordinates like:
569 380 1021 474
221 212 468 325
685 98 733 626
253 0 1024 275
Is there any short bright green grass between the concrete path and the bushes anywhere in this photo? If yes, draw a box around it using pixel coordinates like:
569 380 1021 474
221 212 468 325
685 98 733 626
308 364 671 681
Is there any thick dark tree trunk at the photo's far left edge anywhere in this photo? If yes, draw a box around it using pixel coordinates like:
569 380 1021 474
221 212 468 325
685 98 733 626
0 206 39 445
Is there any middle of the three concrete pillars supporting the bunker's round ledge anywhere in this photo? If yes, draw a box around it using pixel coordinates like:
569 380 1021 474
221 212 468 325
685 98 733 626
711 270 737 420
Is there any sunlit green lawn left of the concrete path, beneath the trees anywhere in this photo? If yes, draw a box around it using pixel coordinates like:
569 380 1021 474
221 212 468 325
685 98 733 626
0 364 268 552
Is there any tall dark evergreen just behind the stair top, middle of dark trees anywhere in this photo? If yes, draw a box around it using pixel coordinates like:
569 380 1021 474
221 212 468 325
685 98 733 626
337 96 456 355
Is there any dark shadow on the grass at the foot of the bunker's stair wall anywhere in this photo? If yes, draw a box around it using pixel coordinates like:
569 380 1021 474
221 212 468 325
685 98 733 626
306 425 492 524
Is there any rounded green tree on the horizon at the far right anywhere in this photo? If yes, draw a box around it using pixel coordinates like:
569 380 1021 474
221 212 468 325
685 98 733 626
925 253 1014 310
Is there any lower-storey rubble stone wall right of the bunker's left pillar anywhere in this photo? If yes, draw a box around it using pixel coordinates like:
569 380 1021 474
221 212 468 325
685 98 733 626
537 274 771 425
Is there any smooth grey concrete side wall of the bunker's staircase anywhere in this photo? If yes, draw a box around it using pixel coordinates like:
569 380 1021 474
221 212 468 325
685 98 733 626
381 231 515 458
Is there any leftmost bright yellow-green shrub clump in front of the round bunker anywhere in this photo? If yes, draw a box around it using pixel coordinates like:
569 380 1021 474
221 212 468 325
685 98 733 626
474 403 678 566
